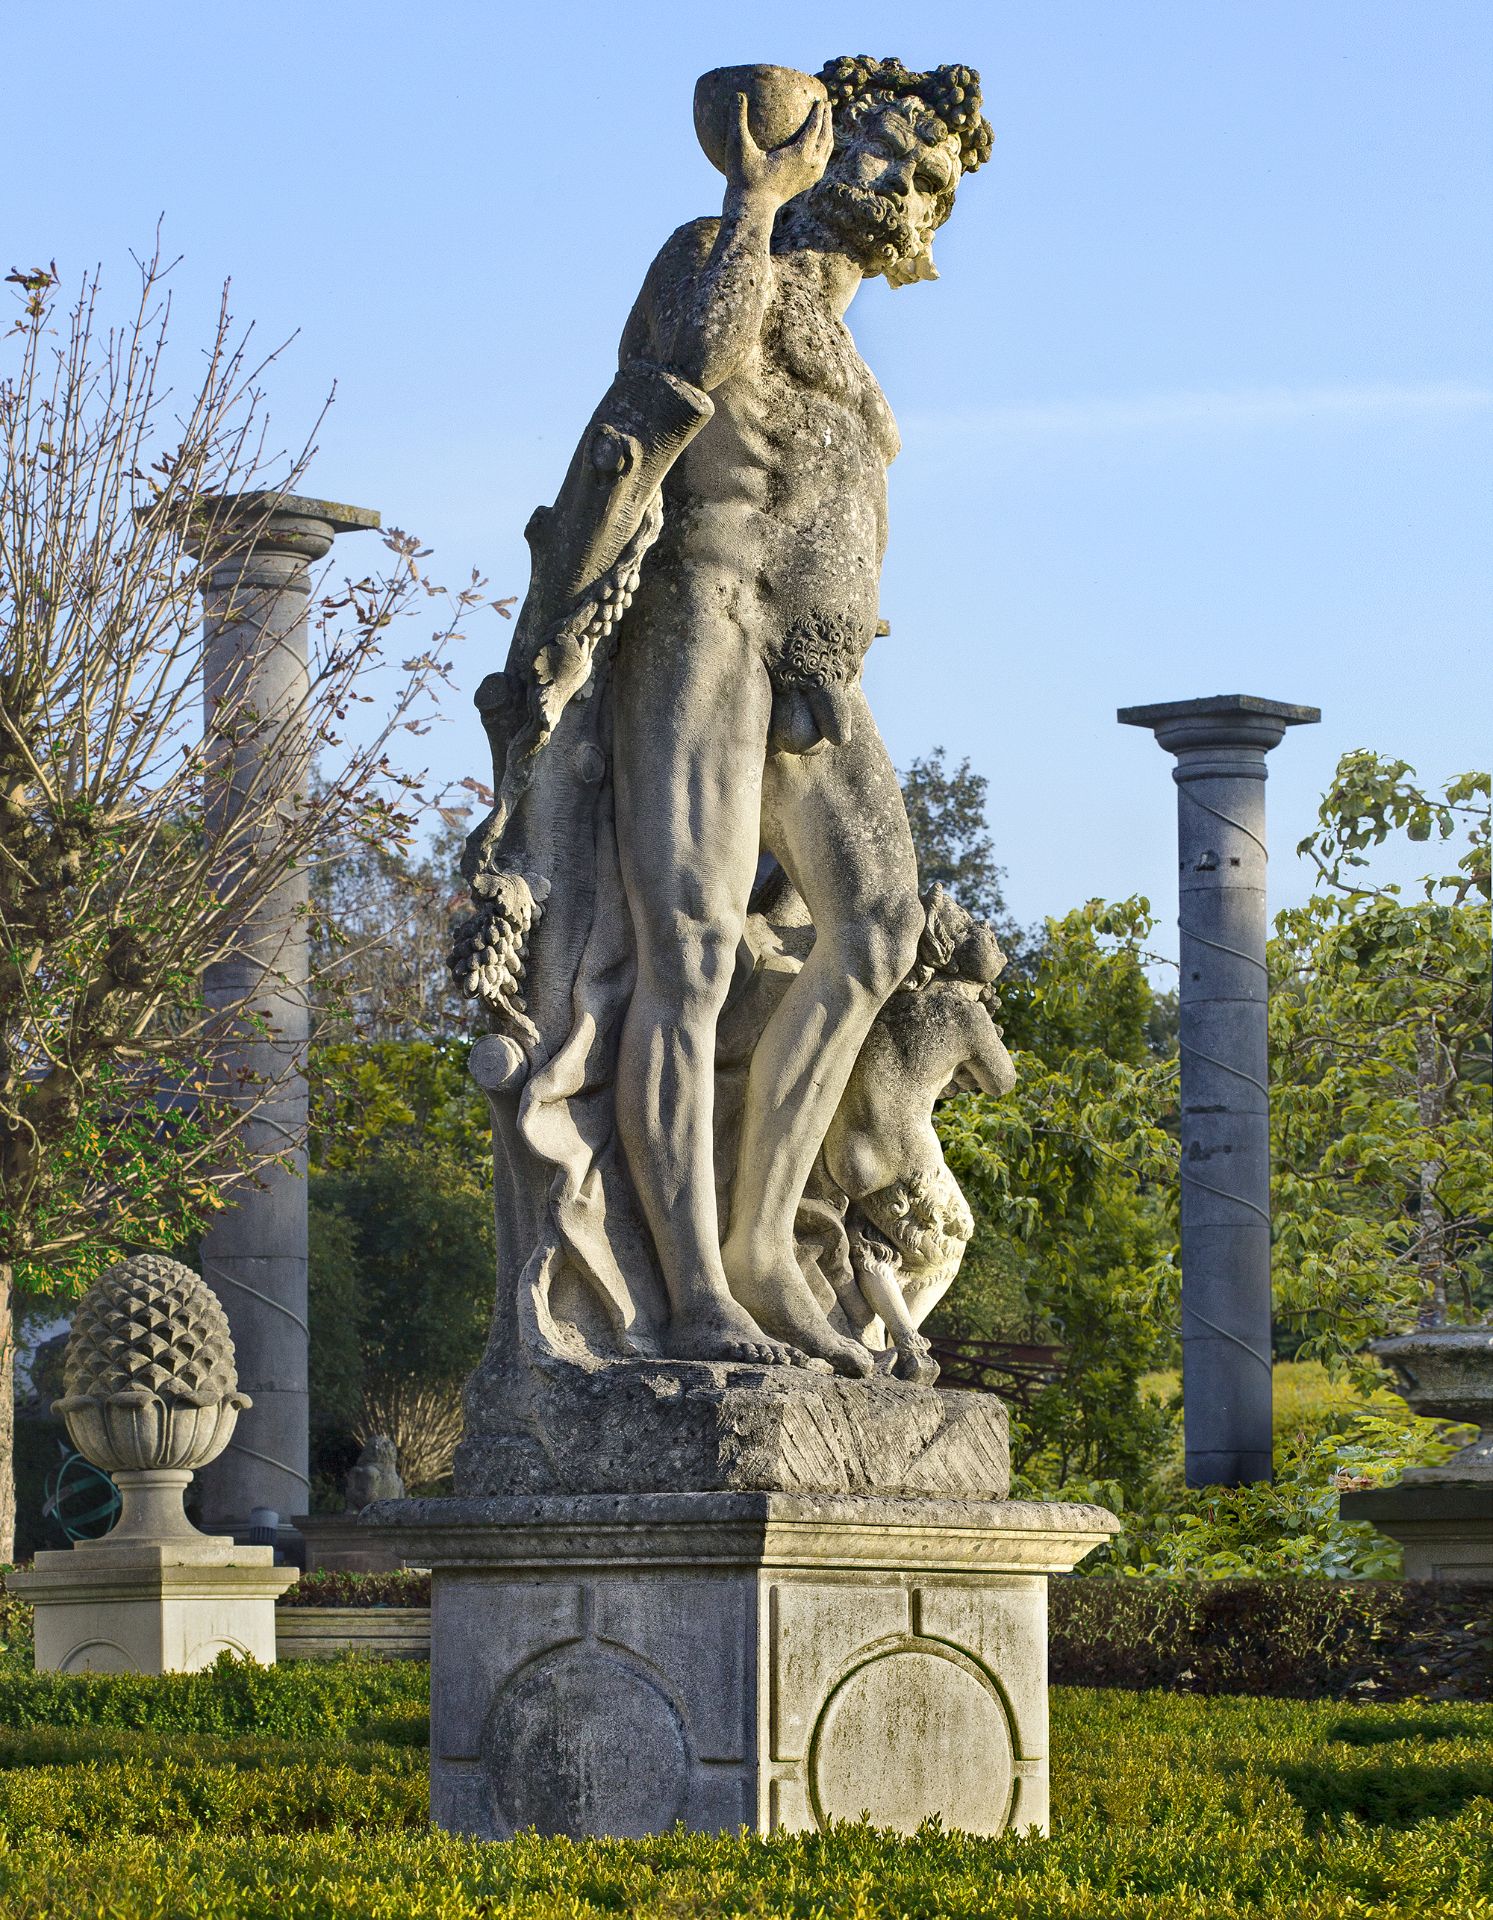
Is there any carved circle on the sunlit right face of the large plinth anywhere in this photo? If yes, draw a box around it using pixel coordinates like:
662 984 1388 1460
808 1640 1015 1834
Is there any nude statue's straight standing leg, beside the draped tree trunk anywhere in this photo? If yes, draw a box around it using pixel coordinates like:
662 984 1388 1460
612 597 793 1361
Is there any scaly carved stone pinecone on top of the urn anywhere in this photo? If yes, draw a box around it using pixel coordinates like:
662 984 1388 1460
63 1254 238 1407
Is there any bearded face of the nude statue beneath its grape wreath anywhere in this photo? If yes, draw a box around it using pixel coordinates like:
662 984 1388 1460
802 106 960 286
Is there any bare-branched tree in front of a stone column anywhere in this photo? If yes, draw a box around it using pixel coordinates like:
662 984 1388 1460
0 248 489 1563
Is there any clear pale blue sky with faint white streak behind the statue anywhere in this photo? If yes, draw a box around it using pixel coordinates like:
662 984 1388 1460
4 0 1493 947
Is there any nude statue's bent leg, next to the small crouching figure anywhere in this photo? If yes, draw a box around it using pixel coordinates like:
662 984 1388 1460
722 687 923 1373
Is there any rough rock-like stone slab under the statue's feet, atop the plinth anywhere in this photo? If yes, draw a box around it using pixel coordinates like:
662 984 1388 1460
455 1361 1011 1500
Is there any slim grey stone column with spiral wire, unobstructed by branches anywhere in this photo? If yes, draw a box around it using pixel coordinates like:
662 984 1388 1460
1117 693 1322 1486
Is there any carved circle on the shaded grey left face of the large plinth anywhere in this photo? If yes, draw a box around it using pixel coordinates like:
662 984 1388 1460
482 1645 689 1839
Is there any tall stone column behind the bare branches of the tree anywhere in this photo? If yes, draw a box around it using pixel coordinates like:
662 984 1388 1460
189 493 380 1530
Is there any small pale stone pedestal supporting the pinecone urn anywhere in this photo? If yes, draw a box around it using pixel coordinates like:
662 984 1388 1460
6 1536 299 1674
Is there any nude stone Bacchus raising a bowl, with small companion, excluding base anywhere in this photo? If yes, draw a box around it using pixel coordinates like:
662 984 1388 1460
455 60 1009 1377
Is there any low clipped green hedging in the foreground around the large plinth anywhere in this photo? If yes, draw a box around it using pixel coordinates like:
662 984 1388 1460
0 1663 1493 1920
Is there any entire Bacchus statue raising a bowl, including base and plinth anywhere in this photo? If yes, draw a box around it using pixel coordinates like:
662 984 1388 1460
378 74 1119 1839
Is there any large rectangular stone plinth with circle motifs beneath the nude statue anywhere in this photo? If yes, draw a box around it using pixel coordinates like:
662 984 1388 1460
365 1494 1117 1839
